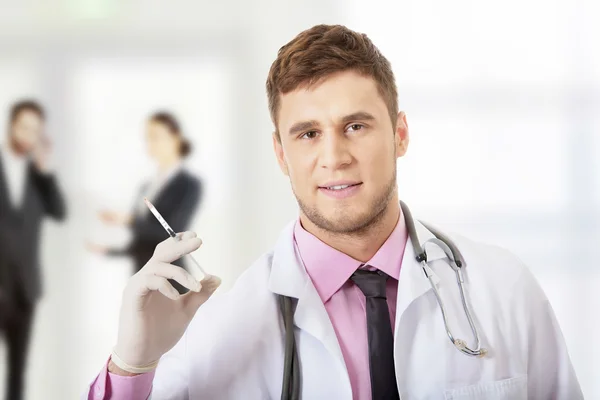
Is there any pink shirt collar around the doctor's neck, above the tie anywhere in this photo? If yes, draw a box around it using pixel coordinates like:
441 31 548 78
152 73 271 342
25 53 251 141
294 212 408 303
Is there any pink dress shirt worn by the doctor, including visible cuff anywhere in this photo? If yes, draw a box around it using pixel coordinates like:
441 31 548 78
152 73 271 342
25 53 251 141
88 215 408 400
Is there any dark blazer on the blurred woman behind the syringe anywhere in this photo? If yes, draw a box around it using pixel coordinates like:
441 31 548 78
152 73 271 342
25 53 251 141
109 170 202 272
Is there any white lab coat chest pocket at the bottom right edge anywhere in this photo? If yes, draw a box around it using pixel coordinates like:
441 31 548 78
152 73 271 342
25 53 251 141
444 375 527 400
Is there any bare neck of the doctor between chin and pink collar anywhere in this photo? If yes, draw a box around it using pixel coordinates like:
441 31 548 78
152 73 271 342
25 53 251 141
300 200 400 263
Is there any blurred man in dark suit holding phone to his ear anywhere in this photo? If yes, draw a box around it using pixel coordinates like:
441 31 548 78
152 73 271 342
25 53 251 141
0 100 66 400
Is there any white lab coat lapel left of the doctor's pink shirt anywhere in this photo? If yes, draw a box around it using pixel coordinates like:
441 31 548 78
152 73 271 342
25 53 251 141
269 221 345 368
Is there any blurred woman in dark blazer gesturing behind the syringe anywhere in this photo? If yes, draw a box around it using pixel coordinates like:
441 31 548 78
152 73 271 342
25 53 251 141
88 111 202 282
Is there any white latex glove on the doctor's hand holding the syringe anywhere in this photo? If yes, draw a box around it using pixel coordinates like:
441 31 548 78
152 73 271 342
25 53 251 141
114 232 221 367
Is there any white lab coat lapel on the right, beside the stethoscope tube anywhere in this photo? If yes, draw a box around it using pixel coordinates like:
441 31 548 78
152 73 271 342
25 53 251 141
395 220 446 324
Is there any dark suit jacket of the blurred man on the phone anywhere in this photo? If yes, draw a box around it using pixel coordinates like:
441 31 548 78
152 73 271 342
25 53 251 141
0 155 66 303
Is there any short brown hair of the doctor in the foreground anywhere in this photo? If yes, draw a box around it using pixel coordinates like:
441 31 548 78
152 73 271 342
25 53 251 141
267 25 398 137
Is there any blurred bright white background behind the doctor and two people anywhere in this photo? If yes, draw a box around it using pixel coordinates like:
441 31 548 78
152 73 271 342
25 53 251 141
0 0 600 400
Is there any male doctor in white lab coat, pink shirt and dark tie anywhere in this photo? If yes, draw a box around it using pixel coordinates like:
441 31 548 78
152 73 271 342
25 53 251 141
87 25 582 400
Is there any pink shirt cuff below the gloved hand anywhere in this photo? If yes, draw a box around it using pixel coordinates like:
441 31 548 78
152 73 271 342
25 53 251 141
88 362 155 400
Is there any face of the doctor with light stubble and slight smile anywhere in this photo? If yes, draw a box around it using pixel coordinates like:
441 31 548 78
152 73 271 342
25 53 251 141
273 71 408 234
